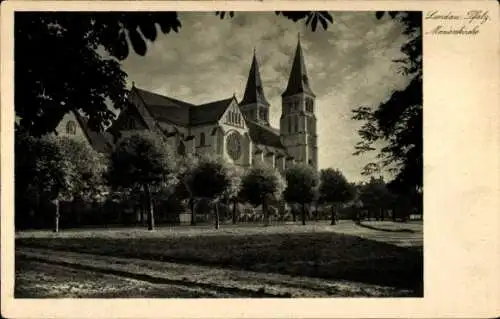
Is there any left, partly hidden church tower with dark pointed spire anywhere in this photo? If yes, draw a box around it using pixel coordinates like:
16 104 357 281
240 49 269 125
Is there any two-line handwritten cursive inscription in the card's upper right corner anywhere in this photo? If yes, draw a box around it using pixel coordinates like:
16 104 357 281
424 10 490 36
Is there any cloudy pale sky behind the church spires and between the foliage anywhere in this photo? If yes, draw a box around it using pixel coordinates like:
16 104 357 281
122 12 408 182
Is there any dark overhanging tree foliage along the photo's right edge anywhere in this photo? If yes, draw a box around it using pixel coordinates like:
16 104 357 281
353 11 423 192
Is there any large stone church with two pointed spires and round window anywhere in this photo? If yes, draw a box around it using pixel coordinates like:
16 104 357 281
109 39 318 172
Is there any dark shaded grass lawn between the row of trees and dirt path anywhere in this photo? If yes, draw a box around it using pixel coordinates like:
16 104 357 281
16 224 423 296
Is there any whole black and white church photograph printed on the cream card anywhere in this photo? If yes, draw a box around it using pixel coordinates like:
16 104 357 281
10 11 424 298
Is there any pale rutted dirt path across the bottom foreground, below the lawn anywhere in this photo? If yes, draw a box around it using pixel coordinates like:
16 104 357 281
16 247 412 298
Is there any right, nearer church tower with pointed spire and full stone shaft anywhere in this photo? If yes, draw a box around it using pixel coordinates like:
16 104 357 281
280 38 318 169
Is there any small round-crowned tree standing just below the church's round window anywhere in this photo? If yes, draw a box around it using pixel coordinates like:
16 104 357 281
186 156 239 229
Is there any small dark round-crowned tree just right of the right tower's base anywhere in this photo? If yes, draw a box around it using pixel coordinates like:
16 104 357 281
319 168 354 225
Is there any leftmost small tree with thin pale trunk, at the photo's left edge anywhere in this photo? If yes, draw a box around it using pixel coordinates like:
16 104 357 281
14 131 73 232
